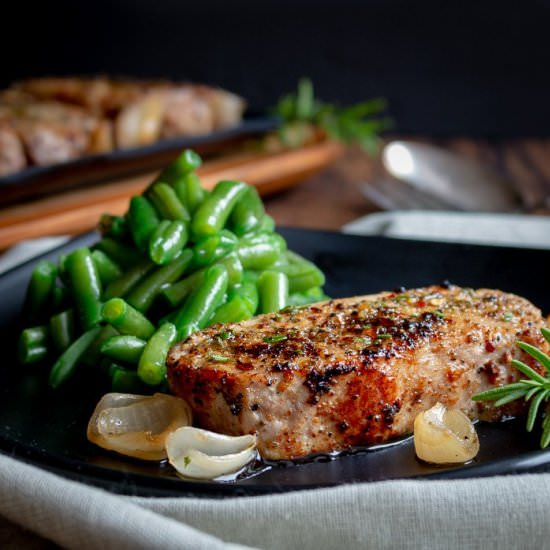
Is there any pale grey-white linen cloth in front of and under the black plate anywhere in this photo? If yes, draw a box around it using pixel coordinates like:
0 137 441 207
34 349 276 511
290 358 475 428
0 455 550 550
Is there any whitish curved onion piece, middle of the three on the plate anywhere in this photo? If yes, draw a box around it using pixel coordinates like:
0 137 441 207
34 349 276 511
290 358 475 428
166 427 256 479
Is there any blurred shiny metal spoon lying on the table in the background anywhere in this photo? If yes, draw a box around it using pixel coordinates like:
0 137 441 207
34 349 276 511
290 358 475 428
382 141 521 212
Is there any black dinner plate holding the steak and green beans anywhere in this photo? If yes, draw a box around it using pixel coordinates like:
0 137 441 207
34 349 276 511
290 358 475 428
0 229 550 496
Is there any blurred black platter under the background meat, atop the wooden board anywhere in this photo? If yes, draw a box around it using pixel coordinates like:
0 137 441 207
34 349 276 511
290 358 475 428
0 115 278 206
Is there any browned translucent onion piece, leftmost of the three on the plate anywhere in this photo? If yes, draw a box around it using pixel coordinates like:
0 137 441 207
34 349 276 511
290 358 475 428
87 393 192 460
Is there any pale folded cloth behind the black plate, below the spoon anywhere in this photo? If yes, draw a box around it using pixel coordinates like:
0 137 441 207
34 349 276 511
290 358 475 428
342 210 550 249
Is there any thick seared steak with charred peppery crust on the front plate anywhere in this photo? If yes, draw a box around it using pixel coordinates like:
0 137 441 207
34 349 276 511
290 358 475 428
167 286 549 460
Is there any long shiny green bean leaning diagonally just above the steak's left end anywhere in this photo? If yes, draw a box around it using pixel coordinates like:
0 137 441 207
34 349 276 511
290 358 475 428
174 265 228 340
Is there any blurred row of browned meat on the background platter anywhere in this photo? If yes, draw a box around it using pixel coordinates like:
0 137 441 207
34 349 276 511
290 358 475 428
0 77 245 175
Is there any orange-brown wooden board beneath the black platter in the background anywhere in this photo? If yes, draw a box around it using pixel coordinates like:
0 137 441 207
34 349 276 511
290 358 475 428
0 141 343 249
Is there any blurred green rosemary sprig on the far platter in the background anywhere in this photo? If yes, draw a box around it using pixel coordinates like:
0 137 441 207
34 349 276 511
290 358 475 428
273 78 391 152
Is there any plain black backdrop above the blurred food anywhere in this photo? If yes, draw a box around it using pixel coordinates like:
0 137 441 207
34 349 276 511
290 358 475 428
0 0 550 137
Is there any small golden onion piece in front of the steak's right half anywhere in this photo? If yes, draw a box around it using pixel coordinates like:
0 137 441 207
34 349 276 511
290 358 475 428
414 403 479 464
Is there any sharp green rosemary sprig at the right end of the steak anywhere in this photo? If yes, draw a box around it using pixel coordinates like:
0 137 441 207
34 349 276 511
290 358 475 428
472 328 550 449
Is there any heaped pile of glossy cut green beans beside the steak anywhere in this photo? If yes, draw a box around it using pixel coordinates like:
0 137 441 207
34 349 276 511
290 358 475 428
18 150 326 392
